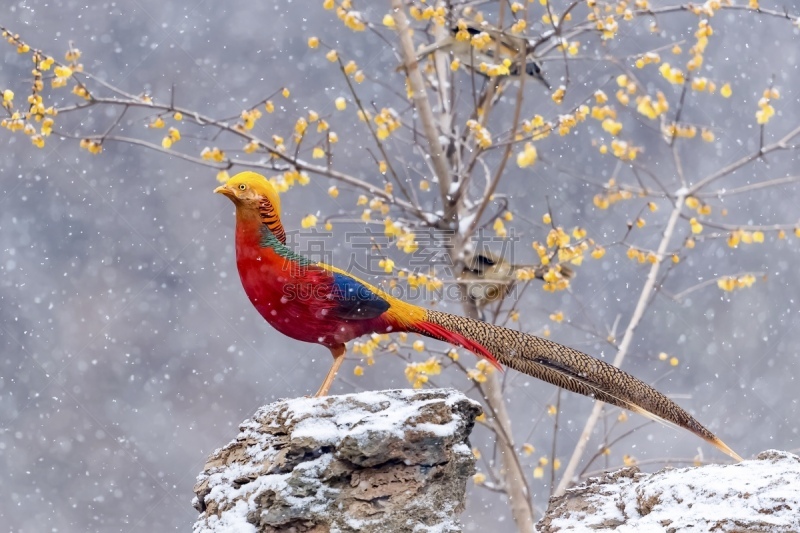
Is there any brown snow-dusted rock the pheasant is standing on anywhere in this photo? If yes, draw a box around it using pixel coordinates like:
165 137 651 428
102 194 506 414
193 389 481 533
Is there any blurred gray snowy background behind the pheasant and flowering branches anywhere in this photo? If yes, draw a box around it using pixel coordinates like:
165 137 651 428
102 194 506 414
0 0 800 532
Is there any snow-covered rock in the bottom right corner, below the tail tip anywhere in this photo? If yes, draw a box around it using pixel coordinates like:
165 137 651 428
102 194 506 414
537 450 800 533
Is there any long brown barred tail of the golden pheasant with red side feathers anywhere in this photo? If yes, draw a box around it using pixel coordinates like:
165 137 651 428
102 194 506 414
412 310 742 461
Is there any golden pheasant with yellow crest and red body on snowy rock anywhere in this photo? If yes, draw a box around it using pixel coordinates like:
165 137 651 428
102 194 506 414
214 172 741 460
